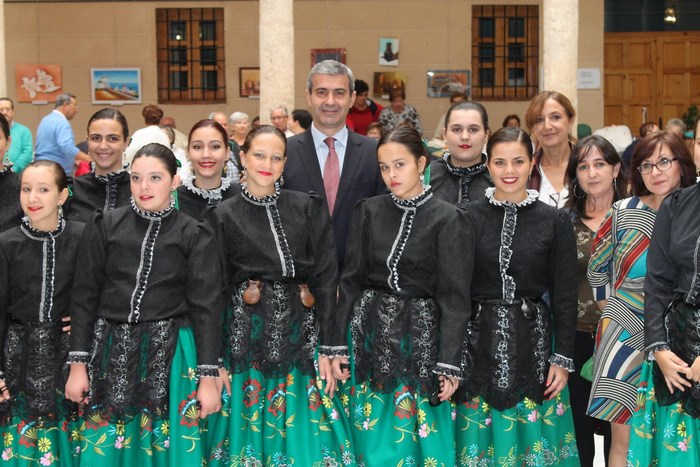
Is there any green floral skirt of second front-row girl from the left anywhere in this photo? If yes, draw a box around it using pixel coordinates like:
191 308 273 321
72 327 206 467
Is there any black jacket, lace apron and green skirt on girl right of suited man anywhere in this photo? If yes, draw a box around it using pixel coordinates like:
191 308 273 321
335 189 473 467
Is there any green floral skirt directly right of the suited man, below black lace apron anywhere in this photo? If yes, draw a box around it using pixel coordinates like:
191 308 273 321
341 383 455 467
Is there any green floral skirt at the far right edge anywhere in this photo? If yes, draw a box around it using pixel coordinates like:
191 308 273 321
627 362 700 467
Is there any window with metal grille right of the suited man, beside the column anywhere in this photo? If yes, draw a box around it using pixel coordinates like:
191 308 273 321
472 5 539 100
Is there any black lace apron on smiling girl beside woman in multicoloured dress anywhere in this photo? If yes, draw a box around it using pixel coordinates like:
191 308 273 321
456 299 552 410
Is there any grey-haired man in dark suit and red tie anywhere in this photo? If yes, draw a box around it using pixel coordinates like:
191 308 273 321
284 60 386 267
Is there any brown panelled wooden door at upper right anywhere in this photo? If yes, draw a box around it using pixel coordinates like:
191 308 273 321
604 32 700 134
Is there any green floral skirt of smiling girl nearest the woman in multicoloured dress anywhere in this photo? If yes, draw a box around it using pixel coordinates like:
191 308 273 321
455 386 579 466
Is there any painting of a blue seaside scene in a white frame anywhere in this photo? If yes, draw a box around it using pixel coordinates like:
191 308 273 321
90 68 141 105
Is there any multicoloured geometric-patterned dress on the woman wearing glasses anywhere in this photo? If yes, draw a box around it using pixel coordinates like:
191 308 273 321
588 196 656 424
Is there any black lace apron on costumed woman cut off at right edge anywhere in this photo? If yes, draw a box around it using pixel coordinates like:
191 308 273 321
653 300 700 418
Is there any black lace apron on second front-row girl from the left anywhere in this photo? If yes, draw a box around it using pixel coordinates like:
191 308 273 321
86 318 183 419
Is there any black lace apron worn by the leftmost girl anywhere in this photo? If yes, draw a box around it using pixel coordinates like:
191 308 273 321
0 321 77 424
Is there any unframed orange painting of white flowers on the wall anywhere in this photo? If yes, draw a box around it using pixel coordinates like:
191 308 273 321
15 65 63 102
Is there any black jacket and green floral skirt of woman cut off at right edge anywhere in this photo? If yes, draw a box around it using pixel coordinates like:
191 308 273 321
628 184 700 467
